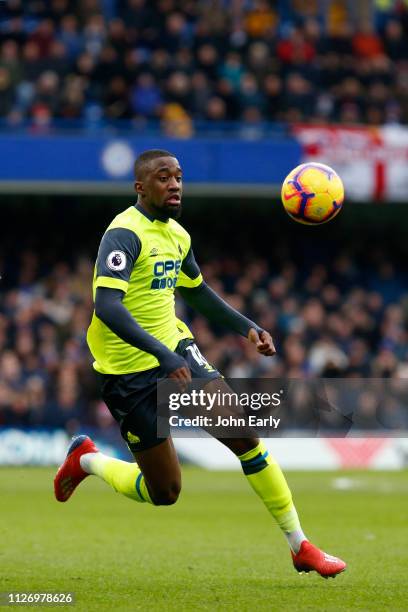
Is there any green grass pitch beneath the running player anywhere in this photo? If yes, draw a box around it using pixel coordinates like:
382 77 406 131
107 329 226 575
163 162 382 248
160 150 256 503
0 468 408 612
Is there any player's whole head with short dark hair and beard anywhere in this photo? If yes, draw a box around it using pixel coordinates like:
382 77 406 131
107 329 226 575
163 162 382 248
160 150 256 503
135 149 183 219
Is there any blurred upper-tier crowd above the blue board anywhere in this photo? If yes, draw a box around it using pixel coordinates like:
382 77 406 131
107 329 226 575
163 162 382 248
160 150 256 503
0 0 408 130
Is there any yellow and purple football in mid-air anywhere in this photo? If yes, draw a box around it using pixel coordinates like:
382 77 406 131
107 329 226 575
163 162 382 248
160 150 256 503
281 162 344 225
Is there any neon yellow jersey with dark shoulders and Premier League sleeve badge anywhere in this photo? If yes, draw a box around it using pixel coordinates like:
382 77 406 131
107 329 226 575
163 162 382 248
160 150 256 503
87 206 202 374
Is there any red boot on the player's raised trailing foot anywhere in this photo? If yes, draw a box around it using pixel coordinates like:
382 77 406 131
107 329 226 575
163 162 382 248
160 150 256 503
54 436 98 502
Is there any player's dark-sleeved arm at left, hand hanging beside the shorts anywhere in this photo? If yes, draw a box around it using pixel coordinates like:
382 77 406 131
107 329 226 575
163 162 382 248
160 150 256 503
95 287 191 382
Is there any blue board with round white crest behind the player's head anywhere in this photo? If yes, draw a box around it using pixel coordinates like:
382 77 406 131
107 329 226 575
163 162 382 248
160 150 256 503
0 133 301 185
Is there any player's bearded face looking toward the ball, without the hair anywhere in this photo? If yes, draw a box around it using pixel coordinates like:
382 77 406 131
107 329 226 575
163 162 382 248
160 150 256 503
136 157 183 219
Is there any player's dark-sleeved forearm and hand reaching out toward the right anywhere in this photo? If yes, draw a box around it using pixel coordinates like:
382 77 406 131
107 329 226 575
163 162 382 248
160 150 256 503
178 282 276 356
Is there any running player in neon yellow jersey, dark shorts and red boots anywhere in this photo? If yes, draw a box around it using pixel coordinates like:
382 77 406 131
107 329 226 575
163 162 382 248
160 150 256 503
54 150 346 578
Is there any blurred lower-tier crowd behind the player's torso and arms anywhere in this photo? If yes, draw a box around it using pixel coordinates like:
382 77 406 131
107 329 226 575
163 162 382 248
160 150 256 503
0 244 408 433
